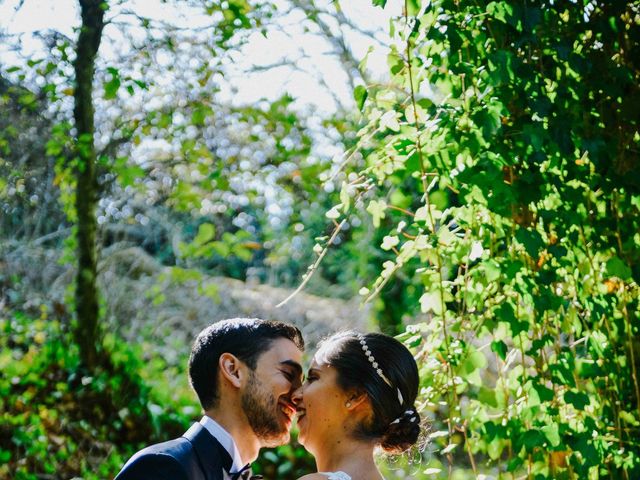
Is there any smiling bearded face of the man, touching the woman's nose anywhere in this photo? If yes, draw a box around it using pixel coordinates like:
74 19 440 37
241 338 302 447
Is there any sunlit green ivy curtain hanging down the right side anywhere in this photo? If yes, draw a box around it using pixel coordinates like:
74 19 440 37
319 0 640 479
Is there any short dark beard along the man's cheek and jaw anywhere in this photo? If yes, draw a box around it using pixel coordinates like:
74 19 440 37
241 372 289 447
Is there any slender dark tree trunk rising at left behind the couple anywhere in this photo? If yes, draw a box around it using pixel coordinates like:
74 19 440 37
73 0 107 369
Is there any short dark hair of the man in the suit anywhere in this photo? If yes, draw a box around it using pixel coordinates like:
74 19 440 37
189 318 304 410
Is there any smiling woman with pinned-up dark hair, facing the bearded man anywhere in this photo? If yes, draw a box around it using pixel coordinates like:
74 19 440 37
292 331 420 480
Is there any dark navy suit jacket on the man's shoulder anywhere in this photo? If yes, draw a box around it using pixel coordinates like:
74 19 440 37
115 423 232 480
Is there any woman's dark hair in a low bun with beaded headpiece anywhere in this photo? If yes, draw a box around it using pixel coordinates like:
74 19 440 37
321 331 421 453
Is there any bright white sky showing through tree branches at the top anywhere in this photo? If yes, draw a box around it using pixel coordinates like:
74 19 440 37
0 0 397 113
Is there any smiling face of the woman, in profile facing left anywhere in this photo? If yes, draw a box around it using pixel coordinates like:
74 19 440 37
292 356 349 452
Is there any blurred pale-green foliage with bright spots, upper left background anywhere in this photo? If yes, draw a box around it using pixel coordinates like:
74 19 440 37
0 0 380 296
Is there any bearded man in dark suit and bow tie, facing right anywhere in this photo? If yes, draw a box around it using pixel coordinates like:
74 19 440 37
116 318 304 480
